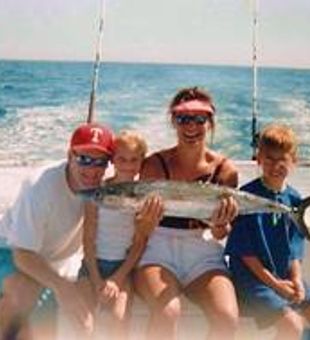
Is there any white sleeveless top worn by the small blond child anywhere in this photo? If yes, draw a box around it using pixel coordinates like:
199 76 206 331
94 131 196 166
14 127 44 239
96 207 134 260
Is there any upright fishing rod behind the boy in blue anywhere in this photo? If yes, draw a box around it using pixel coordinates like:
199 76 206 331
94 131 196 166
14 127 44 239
251 0 259 160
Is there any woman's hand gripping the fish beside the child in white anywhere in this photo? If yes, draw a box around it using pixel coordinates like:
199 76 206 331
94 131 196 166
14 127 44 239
135 194 164 238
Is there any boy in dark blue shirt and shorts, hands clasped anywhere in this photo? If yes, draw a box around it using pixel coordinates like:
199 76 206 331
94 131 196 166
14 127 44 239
226 124 310 340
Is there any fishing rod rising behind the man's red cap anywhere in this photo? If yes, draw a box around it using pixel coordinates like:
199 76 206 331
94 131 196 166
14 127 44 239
87 0 105 123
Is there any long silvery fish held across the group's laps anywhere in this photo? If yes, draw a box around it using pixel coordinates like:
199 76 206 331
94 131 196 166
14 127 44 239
79 181 310 239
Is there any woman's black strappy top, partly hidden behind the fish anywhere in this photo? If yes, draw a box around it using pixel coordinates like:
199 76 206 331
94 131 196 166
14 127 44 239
155 153 226 229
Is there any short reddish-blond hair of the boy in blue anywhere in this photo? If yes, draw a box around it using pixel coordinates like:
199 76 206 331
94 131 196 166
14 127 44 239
258 124 298 160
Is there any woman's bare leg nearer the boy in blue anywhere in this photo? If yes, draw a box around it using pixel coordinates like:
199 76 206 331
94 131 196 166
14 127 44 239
185 271 238 340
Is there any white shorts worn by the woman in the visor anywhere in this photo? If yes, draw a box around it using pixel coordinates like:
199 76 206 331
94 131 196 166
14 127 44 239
138 227 228 287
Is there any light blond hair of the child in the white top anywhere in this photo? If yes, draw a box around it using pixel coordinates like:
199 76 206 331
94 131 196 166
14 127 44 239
115 130 147 158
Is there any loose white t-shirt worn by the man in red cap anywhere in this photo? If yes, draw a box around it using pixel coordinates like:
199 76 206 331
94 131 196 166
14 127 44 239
7 162 83 275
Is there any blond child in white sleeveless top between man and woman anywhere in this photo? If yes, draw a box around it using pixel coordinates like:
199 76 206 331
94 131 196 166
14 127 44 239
80 130 163 340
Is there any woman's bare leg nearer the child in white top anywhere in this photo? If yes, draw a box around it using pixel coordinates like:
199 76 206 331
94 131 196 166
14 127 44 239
134 265 181 340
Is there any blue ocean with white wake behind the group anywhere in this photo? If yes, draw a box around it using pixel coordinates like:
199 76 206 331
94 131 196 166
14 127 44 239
0 60 310 165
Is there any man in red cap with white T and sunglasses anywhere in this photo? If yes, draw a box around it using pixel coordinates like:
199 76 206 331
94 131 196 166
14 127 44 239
0 124 114 340
